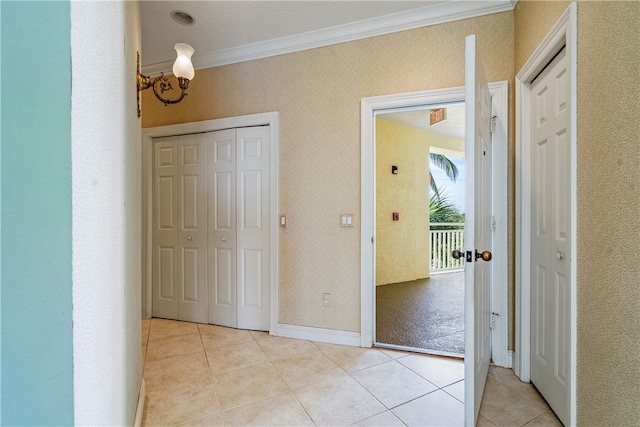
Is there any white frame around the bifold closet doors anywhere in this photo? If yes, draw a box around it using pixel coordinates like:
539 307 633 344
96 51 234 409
142 112 279 335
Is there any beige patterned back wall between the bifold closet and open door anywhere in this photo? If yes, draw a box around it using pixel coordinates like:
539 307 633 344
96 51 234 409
142 12 513 331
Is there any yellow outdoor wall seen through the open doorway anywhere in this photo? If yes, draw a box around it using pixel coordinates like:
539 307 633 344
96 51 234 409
376 119 430 285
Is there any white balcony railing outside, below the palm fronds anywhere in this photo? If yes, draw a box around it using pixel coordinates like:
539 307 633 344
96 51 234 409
429 222 464 273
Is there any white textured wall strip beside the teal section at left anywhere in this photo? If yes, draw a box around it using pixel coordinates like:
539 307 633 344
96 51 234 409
71 1 142 426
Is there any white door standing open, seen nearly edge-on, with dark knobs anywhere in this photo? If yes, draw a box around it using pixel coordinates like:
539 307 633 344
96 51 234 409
464 35 492 426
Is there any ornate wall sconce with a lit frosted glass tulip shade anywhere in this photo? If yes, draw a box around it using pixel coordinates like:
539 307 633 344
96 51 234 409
137 43 195 117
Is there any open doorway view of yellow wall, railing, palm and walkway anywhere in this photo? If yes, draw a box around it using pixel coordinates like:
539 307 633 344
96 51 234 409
375 102 465 357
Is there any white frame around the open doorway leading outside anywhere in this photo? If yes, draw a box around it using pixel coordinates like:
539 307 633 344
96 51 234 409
360 81 511 367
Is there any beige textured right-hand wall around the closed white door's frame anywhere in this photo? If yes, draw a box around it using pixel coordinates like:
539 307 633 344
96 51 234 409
515 1 640 426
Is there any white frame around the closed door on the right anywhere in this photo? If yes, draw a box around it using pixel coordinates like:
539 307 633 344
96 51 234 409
513 2 578 425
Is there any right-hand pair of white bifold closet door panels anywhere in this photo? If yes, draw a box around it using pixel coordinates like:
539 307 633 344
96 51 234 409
208 126 270 330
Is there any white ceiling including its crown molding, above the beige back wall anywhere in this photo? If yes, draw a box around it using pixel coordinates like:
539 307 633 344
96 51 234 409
141 0 515 75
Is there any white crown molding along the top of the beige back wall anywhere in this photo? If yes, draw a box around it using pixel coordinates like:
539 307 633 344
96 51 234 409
142 0 516 75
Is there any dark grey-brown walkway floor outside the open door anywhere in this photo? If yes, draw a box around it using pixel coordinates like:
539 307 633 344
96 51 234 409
376 272 464 355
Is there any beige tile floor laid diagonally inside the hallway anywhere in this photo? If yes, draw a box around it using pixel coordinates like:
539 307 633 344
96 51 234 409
142 319 561 427
